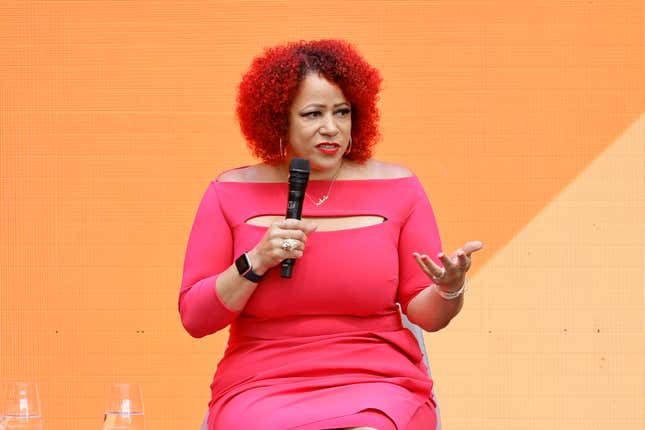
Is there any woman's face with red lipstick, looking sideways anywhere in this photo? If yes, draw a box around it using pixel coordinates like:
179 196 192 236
287 73 352 173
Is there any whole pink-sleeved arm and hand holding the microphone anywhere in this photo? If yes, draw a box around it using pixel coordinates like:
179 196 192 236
179 182 315 337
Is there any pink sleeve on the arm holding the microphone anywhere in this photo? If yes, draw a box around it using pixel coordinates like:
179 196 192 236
179 182 237 337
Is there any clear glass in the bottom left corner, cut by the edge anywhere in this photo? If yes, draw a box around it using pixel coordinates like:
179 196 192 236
0 382 43 430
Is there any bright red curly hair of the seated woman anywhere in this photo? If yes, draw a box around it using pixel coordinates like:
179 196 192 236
237 39 381 164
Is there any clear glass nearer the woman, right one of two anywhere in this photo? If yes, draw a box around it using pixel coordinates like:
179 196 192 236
103 383 145 430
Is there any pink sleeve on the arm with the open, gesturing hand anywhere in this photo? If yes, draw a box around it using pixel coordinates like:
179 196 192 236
397 176 441 313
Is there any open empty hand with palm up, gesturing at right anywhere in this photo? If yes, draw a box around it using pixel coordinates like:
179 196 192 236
413 241 484 293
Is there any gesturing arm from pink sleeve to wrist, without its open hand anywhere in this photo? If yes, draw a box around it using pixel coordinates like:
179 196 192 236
398 178 464 331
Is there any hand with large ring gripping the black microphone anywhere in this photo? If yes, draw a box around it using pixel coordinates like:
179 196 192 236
247 219 316 275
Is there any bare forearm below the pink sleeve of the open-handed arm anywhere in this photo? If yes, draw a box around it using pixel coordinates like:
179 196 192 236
407 285 464 331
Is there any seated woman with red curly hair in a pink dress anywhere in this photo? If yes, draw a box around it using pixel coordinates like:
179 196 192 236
179 40 482 430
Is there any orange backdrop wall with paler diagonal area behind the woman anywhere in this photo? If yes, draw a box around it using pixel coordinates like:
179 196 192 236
0 0 645 430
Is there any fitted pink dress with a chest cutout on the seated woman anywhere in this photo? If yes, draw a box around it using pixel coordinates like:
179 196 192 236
179 176 441 430
